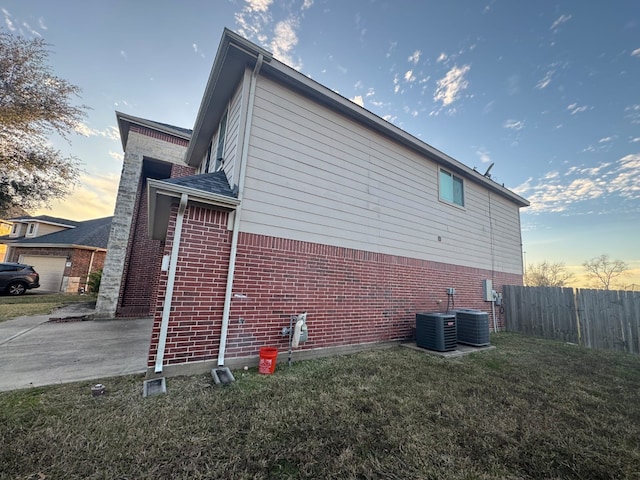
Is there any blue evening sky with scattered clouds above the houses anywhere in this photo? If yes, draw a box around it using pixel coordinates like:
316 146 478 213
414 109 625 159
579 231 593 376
0 0 640 290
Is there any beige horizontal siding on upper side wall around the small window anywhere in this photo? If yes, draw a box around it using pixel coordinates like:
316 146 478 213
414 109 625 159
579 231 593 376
241 77 521 273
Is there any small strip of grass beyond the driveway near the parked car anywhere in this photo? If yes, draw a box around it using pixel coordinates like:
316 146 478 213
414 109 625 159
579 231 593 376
0 292 95 322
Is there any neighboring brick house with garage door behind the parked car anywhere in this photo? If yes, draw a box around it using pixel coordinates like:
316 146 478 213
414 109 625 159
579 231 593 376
0 215 111 293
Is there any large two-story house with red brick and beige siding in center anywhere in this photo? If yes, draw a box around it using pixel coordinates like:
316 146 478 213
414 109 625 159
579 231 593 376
92 30 528 374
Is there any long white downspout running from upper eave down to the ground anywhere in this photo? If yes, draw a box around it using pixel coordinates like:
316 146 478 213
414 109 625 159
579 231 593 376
218 54 264 367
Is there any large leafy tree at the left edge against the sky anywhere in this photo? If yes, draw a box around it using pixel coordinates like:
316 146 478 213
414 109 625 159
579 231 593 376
0 32 87 215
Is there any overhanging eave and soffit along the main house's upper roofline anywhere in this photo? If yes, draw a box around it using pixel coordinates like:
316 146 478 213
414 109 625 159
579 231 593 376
185 28 529 207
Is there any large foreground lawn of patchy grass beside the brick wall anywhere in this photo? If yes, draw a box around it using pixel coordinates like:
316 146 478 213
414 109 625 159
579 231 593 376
0 333 640 479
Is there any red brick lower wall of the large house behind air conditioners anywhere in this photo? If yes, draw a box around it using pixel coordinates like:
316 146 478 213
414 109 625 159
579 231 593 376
149 206 522 366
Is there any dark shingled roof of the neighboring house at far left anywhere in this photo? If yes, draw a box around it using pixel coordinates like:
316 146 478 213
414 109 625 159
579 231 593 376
3 217 113 249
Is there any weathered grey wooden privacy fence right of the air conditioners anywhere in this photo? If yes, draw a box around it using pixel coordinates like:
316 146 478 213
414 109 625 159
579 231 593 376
503 285 640 354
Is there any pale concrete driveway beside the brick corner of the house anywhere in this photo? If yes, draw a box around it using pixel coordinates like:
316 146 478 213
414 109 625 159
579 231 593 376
0 304 153 391
